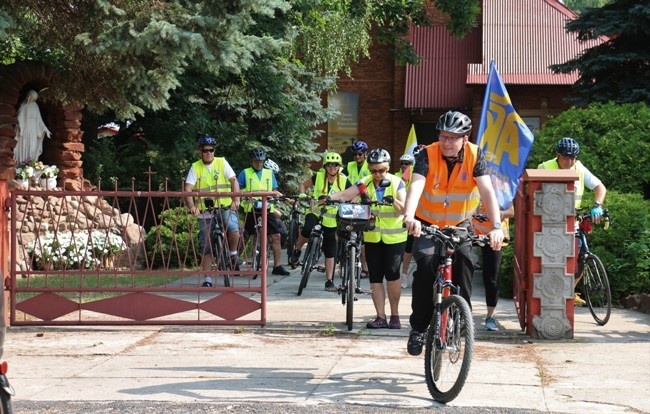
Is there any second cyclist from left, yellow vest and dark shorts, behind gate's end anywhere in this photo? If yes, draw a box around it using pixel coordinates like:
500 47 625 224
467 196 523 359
237 148 290 276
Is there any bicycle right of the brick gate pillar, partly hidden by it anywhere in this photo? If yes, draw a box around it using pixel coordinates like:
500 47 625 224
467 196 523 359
576 210 612 326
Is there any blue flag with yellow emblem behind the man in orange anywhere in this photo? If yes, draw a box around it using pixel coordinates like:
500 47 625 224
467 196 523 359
477 61 534 209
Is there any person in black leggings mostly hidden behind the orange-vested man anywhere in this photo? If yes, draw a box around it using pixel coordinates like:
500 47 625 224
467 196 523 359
472 204 515 331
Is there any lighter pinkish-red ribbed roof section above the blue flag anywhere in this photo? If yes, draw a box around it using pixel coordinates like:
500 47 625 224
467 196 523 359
467 0 601 85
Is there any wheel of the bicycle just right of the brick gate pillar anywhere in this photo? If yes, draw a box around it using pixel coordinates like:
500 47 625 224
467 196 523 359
582 254 612 326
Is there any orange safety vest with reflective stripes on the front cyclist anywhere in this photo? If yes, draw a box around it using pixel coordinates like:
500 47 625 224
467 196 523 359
415 142 480 227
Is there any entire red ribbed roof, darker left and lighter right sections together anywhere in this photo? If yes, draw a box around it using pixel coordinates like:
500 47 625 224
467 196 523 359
404 0 602 109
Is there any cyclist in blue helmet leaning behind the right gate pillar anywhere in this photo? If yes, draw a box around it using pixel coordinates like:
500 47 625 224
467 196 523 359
537 137 607 305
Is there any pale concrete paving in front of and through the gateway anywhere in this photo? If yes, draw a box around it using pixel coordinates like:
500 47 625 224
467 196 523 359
3 264 650 413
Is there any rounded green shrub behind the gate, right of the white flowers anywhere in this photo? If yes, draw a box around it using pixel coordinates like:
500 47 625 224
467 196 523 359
145 207 199 269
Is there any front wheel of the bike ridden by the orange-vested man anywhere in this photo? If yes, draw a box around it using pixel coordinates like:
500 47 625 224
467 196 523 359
424 295 474 403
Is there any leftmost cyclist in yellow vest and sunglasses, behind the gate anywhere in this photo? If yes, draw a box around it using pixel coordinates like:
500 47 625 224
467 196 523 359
185 136 239 287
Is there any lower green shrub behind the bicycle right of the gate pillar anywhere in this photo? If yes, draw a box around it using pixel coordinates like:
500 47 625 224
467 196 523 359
499 191 650 303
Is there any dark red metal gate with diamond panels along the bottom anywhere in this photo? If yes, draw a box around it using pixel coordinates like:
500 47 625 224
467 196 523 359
0 181 271 325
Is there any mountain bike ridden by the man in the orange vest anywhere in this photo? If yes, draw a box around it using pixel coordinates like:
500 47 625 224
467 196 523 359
420 226 489 403
